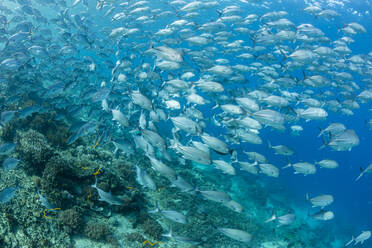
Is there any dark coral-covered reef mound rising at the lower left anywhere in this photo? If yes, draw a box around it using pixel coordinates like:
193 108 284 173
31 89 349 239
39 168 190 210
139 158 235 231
0 113 163 248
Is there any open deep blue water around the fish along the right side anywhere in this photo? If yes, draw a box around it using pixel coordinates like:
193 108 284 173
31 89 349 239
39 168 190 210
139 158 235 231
201 1 372 243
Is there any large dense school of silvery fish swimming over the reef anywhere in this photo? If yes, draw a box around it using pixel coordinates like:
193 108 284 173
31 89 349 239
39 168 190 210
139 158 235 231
0 0 372 245
